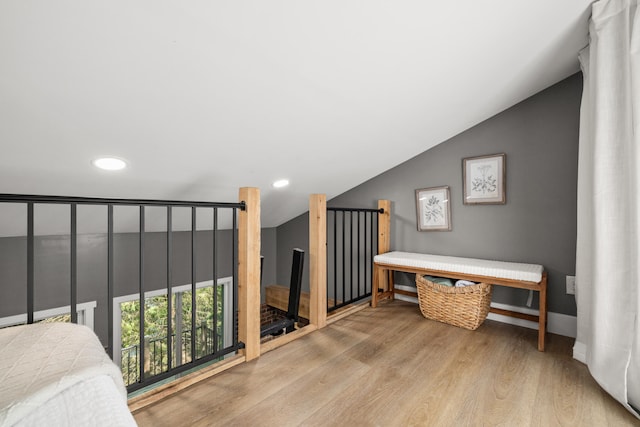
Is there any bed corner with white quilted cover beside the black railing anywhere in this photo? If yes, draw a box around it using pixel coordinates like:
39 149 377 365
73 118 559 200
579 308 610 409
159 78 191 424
0 323 136 426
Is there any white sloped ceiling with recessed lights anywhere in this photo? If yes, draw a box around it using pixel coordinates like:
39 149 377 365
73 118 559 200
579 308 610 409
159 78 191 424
0 0 591 227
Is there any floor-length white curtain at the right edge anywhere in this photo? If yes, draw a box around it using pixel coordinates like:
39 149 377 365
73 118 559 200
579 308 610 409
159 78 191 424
574 0 640 418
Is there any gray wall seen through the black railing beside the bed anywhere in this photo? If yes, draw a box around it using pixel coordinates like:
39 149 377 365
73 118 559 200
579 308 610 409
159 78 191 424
0 228 276 344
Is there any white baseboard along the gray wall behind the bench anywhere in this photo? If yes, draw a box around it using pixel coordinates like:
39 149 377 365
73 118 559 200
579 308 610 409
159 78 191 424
395 285 580 340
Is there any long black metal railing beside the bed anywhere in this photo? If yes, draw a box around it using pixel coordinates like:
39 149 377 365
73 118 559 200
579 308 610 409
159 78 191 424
0 189 249 391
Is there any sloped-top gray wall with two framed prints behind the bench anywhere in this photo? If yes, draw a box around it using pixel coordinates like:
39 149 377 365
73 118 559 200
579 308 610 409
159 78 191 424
277 74 582 315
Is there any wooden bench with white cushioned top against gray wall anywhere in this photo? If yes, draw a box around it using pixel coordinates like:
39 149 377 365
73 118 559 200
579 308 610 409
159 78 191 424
371 252 547 351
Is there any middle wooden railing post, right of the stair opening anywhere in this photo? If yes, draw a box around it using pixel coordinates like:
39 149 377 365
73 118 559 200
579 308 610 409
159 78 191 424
309 194 327 328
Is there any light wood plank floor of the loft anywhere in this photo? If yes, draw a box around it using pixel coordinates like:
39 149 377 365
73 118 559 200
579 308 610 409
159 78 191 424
134 301 640 426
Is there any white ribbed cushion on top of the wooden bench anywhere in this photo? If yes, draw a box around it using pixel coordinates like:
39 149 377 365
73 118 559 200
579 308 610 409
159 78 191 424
373 251 544 283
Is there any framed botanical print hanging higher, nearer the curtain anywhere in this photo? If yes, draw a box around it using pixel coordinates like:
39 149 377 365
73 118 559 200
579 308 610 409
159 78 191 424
462 153 507 205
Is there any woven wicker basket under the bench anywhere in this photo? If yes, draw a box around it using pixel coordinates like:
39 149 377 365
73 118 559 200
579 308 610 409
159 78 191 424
416 274 491 331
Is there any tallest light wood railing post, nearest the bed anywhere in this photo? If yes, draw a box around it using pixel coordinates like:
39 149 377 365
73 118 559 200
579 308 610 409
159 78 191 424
238 187 260 361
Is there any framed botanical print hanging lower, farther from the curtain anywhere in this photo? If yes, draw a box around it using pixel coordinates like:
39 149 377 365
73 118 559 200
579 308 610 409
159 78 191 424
416 185 451 231
